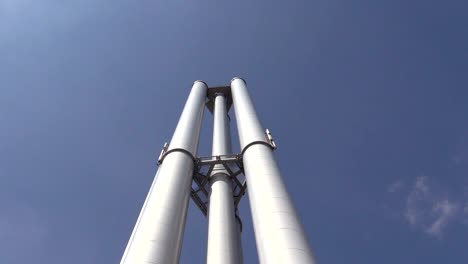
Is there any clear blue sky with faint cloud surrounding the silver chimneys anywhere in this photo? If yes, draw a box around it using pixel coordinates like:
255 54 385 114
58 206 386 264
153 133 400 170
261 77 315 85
0 0 468 264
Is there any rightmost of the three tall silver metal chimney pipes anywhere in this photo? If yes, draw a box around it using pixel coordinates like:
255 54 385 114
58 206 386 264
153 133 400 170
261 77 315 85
231 78 315 264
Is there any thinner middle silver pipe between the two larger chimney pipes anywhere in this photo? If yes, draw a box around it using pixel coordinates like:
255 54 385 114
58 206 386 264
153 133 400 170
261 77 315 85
206 94 242 264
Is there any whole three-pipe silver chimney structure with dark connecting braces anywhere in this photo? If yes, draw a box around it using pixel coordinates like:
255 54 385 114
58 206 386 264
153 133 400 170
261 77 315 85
120 77 315 264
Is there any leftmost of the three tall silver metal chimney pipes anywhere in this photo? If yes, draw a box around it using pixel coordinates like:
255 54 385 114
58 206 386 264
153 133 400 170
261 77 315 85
120 81 207 264
